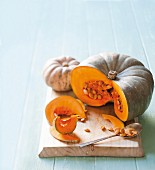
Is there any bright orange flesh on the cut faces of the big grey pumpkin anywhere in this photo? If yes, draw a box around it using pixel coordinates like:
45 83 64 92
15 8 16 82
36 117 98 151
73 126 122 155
71 66 128 121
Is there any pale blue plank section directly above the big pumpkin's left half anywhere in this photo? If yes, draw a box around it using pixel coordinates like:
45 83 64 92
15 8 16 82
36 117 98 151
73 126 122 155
86 1 116 55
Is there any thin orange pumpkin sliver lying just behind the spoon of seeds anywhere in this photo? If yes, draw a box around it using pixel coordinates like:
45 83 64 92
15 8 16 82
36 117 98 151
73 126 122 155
102 114 124 128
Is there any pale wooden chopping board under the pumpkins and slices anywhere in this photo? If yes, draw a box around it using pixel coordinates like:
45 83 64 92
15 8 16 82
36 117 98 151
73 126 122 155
39 89 144 158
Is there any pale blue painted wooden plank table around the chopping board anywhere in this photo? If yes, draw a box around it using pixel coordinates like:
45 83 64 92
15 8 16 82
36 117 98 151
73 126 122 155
0 0 155 170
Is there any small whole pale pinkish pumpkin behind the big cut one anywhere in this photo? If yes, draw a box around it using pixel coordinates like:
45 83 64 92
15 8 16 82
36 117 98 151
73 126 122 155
43 56 79 91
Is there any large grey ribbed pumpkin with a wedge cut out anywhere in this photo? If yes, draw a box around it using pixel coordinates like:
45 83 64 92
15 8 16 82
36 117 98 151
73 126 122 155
71 53 154 121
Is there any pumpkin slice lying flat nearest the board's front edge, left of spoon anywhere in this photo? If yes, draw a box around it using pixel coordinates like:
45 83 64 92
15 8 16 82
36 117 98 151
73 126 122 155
50 126 80 143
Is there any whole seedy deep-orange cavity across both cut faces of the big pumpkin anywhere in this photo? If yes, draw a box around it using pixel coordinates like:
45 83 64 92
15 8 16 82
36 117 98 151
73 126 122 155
83 80 123 112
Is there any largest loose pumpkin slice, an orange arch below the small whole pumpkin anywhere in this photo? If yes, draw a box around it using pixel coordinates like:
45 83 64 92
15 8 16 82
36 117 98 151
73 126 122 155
45 96 86 125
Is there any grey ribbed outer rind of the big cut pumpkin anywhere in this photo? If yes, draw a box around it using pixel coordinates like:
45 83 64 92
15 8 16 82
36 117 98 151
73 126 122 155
73 53 154 121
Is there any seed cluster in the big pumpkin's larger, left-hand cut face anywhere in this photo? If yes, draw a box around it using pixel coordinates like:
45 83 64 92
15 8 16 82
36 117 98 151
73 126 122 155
83 80 112 100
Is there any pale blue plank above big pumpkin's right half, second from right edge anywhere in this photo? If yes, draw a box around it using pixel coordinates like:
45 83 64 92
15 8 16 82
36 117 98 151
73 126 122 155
109 0 148 68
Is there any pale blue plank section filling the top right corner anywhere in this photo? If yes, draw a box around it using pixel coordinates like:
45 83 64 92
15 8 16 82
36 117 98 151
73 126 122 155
131 0 155 75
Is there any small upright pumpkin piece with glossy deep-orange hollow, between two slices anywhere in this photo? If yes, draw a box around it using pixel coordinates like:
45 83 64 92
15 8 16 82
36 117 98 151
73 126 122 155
53 115 78 134
